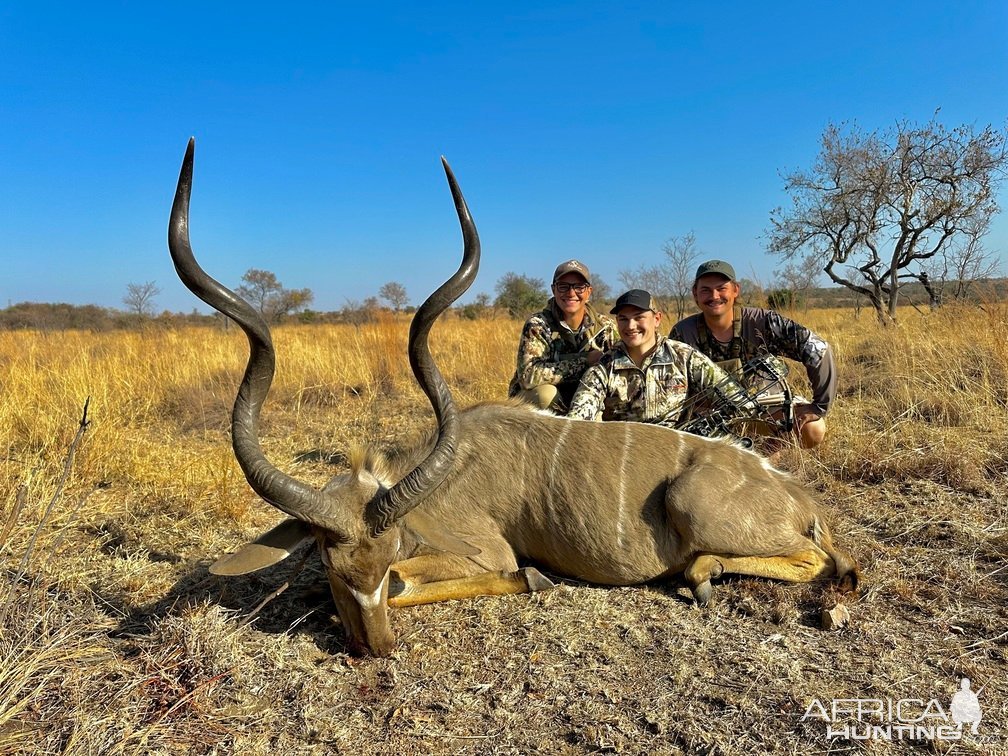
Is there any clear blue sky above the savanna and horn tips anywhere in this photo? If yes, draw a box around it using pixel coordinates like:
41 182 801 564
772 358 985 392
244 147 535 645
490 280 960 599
0 1 1008 311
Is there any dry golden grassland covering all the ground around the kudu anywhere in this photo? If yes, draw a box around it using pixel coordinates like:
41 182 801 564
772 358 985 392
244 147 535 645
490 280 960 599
0 304 1008 754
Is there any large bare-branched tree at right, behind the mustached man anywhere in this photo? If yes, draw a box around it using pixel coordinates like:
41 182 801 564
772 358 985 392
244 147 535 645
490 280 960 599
767 120 1008 323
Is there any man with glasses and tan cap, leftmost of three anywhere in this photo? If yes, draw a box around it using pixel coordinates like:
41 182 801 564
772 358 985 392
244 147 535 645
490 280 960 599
508 260 619 414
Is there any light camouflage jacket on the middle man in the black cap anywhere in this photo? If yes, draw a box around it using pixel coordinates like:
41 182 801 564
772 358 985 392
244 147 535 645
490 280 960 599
568 339 755 427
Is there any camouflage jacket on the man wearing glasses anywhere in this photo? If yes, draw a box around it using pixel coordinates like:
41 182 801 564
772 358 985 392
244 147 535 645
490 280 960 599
508 297 620 409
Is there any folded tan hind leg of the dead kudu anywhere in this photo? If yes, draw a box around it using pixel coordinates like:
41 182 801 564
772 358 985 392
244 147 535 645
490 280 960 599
684 546 837 606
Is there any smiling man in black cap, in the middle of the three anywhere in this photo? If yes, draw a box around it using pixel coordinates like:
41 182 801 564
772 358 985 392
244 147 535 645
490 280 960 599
568 288 754 427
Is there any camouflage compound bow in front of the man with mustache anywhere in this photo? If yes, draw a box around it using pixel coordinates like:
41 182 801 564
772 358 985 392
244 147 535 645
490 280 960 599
675 355 794 449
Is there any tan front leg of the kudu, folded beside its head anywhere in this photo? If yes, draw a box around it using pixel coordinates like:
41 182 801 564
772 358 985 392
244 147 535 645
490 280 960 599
388 555 553 607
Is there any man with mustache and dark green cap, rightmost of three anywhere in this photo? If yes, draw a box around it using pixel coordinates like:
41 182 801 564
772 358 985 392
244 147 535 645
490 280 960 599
670 260 837 449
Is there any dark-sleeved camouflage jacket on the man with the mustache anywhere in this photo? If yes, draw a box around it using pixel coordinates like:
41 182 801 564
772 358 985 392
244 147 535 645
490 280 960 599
669 307 837 415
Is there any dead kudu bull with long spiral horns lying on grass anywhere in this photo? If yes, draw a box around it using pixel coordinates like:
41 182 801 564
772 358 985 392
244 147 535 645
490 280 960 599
168 141 857 655
